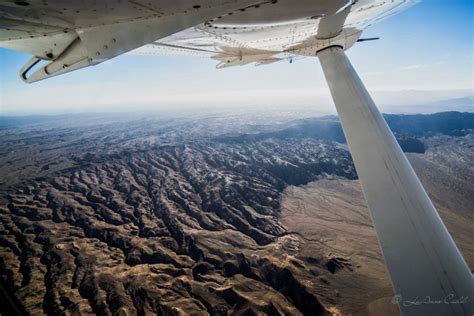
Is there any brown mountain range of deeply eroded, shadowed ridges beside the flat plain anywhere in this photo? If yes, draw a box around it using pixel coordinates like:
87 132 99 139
0 128 355 314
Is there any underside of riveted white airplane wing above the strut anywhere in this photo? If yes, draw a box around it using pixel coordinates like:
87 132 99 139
0 0 413 83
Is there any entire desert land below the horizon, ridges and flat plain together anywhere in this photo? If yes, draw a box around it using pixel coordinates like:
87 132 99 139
0 112 474 315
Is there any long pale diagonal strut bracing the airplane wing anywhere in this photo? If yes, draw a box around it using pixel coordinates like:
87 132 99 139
318 46 474 316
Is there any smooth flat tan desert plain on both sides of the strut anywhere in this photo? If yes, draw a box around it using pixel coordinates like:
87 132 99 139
282 142 474 315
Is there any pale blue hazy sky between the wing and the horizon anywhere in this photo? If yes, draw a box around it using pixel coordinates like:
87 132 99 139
0 0 474 115
